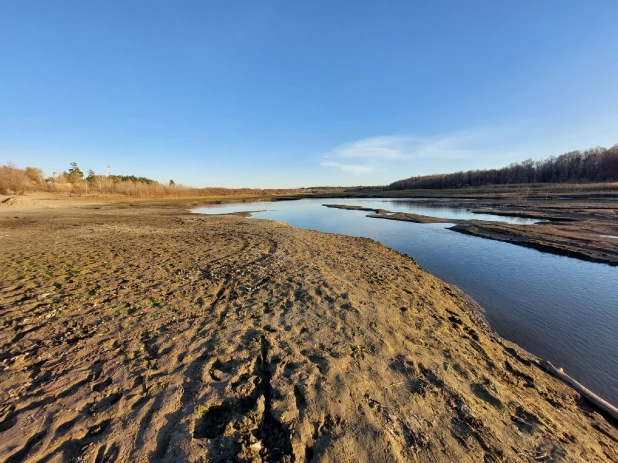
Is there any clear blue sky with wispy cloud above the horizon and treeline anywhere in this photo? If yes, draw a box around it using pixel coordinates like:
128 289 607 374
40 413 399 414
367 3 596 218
0 0 618 187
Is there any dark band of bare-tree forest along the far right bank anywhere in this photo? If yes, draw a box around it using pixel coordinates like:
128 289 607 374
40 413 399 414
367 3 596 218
386 144 618 190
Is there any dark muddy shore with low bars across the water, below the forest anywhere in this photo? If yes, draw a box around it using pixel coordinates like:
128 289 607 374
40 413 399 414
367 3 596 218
325 196 618 266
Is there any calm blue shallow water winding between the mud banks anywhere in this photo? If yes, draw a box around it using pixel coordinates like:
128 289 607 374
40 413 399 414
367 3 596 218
194 199 618 404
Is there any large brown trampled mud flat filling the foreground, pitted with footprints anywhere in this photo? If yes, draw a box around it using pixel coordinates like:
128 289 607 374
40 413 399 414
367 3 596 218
0 205 618 463
